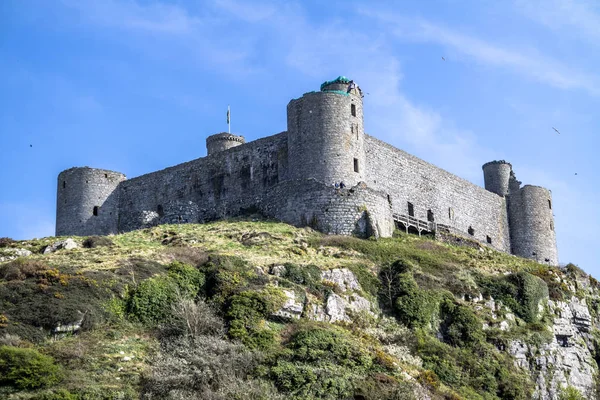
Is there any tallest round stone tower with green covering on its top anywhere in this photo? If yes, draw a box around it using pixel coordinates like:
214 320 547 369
287 76 366 187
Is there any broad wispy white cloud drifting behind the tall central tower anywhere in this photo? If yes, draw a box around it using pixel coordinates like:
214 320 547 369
206 0 491 181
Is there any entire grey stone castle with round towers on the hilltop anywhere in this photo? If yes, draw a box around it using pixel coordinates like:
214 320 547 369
56 76 558 265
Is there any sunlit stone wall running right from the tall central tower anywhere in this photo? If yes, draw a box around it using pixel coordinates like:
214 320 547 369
365 135 510 252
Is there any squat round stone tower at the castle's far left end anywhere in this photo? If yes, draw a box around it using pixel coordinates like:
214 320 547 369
56 167 126 236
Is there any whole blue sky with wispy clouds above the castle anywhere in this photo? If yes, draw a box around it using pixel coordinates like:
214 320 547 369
0 0 600 277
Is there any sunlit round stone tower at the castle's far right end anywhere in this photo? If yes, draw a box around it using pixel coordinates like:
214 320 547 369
508 185 558 265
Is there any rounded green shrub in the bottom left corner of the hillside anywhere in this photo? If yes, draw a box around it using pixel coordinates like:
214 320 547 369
0 346 63 389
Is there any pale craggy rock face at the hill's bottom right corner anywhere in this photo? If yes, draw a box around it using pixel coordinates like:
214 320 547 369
508 297 597 400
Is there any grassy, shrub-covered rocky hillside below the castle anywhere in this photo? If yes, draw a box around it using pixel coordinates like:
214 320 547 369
0 220 600 400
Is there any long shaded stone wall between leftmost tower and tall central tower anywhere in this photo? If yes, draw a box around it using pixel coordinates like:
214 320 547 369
119 133 287 231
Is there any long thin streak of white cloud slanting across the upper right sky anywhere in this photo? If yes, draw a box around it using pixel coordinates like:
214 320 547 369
361 10 600 96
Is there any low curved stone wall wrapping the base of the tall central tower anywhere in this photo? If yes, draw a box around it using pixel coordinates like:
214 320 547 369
260 178 394 237
